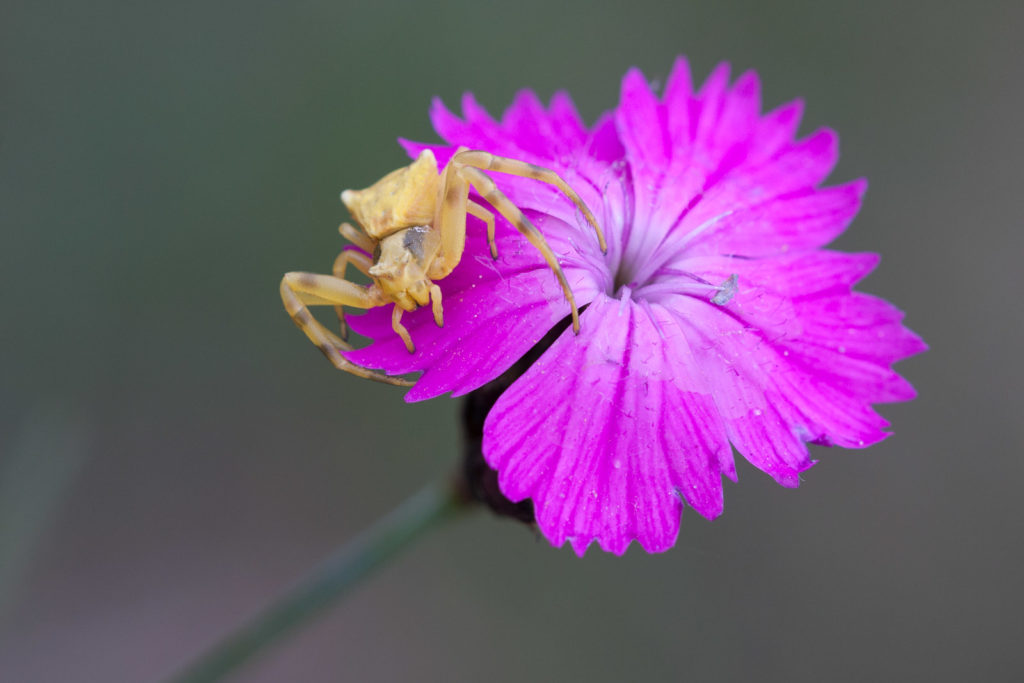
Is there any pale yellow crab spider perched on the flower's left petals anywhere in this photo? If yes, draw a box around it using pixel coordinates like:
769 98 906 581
281 150 607 386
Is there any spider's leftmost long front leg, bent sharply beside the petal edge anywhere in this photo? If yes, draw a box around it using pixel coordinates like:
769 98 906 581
281 272 414 387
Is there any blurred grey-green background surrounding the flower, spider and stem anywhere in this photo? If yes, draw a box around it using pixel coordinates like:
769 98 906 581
0 0 1024 682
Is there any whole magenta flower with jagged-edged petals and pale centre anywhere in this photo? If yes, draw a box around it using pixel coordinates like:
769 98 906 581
348 58 926 555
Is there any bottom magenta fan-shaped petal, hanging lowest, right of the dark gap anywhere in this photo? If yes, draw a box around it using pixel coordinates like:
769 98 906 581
483 296 734 554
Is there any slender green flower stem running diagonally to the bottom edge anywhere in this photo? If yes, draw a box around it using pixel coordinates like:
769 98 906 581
170 483 465 683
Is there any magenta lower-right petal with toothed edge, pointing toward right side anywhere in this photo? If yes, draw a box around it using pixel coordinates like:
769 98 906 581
666 261 921 485
